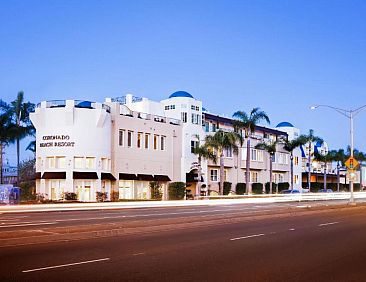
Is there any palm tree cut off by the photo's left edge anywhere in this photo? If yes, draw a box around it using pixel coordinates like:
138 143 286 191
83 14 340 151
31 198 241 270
0 100 14 184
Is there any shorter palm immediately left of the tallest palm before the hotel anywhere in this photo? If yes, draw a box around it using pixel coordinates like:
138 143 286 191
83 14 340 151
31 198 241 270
206 130 240 195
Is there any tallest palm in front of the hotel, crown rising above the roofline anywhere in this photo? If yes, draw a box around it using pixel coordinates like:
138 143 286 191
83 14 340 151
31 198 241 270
233 108 270 194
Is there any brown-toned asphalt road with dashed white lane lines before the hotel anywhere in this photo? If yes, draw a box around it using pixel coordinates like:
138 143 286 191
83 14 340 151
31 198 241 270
0 203 366 281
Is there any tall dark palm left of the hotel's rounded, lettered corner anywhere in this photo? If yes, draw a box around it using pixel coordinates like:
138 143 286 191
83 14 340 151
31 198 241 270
10 91 35 185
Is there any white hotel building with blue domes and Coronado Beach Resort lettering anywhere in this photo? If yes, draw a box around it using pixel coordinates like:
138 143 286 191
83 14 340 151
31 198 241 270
31 91 302 201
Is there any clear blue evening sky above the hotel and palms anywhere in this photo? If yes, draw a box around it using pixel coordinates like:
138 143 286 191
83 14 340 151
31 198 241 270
0 0 366 163
